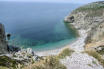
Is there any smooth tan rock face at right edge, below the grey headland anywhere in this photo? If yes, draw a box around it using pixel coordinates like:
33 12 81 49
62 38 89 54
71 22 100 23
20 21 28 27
86 21 104 44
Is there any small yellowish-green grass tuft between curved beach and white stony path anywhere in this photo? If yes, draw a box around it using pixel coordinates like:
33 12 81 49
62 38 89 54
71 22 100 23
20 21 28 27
57 48 74 59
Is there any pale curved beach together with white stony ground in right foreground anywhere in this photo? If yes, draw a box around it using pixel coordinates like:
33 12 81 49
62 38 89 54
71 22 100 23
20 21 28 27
36 26 103 69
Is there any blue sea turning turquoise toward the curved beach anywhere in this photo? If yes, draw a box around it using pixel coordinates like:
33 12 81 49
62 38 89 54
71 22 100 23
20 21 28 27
0 2 80 51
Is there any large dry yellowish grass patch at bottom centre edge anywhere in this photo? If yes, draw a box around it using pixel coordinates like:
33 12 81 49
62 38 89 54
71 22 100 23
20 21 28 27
23 56 66 69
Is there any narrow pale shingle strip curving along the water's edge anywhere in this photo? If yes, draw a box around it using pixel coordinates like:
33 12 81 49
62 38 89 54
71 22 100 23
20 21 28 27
35 26 87 56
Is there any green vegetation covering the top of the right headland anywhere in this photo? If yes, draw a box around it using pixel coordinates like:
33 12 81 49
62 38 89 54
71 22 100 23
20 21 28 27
73 2 104 17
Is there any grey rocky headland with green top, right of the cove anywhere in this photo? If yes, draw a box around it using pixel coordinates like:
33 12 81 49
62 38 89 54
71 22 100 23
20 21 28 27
65 1 104 44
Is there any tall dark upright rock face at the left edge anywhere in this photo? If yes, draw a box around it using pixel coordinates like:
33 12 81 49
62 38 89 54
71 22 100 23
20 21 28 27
0 23 8 54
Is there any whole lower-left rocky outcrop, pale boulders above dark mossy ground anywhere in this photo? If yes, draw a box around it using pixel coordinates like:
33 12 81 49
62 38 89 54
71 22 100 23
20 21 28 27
0 48 41 69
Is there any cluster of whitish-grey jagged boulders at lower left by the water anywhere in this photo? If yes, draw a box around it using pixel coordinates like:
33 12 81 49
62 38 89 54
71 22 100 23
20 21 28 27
13 48 39 62
